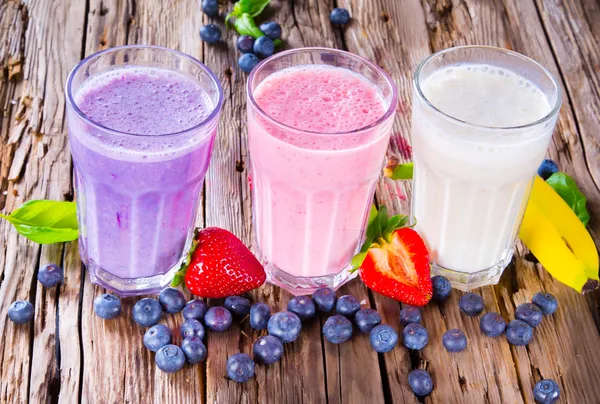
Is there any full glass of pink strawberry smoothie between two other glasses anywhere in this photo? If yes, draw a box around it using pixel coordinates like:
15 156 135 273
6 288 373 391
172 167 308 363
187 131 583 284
247 48 398 295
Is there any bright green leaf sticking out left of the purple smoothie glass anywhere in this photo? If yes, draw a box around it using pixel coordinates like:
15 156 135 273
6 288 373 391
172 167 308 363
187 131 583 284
0 200 78 244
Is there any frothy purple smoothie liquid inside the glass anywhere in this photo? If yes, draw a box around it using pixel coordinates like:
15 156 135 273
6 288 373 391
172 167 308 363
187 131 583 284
69 67 216 279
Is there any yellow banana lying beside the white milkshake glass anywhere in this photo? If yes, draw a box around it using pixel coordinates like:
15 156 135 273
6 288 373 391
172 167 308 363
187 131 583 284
519 176 600 293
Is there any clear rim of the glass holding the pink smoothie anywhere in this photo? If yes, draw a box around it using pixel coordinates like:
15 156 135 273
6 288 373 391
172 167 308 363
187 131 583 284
246 46 398 136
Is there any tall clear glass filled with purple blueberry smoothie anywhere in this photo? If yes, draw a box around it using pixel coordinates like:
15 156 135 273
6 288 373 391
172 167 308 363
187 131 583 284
66 46 223 296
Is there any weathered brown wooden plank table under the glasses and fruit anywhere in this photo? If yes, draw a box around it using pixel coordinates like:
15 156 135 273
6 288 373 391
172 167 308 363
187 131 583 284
0 0 600 404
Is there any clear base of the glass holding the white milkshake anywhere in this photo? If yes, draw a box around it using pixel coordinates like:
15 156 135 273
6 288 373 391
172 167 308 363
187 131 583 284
431 248 515 292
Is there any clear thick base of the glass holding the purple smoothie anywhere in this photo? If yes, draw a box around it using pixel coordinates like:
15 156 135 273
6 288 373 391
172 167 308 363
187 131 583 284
84 256 185 297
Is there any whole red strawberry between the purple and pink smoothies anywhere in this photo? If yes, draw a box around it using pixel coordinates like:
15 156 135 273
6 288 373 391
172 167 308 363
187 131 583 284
172 227 266 298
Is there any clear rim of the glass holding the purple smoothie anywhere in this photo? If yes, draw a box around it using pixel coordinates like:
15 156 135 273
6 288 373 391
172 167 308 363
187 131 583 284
65 45 224 139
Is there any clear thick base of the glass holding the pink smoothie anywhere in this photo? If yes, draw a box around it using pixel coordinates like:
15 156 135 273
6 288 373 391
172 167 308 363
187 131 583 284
263 262 358 296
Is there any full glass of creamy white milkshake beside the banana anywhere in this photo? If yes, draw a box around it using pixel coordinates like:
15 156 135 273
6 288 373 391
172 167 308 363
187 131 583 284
411 46 562 290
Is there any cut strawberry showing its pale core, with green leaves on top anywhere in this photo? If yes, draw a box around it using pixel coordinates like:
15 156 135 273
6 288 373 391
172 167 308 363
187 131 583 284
352 206 433 306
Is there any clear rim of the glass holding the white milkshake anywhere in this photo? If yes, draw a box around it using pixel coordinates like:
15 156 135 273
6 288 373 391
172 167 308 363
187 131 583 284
413 45 562 131
